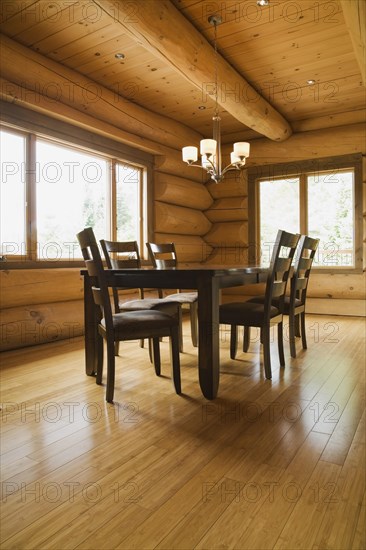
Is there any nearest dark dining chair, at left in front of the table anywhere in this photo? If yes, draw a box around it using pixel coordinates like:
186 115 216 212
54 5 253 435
77 227 181 403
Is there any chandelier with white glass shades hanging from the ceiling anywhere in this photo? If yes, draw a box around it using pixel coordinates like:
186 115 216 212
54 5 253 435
182 15 250 183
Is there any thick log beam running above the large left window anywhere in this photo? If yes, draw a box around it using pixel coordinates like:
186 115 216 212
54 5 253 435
0 34 202 149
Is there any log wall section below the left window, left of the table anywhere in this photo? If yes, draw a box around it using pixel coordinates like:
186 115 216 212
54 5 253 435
0 268 84 350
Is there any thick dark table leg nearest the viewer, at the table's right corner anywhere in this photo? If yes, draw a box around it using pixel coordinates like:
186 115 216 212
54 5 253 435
197 277 220 399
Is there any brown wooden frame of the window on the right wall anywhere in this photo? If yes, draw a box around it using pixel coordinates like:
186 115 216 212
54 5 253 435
248 153 363 274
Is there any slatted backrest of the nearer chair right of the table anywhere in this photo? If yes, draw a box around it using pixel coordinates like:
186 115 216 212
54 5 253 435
265 229 300 317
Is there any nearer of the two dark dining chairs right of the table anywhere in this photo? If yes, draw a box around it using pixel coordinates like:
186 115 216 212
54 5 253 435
219 230 300 379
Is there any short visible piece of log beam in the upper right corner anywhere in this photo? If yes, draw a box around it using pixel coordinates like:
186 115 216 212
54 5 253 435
340 0 366 86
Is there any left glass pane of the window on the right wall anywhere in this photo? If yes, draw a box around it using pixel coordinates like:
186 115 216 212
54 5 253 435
259 178 300 265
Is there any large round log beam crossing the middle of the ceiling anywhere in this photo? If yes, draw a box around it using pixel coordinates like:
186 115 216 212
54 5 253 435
94 0 292 141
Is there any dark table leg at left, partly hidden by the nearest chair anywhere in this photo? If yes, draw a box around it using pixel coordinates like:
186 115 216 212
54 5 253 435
84 275 103 376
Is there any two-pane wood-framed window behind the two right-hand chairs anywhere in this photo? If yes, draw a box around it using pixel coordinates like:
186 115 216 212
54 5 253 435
249 155 362 269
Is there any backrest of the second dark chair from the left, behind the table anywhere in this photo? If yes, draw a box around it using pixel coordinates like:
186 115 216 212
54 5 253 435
100 239 144 313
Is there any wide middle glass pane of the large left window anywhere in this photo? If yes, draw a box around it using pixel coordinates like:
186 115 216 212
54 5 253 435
36 139 109 261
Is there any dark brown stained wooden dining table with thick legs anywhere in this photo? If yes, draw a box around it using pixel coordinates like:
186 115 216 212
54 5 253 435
81 266 268 399
